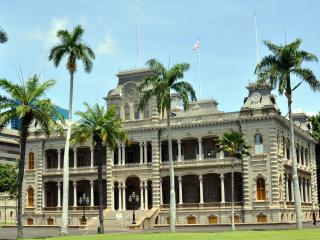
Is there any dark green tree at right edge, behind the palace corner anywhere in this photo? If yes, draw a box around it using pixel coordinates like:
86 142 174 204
308 112 320 202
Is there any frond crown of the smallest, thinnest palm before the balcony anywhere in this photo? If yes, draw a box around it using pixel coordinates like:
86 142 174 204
216 130 250 159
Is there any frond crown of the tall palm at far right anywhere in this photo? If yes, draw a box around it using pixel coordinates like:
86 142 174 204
255 39 320 99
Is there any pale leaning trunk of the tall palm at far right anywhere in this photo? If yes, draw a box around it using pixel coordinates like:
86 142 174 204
288 96 302 229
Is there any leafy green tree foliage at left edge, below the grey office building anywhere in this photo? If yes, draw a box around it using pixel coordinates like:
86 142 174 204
0 163 18 197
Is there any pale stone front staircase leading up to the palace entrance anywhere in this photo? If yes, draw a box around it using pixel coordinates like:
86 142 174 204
86 208 159 230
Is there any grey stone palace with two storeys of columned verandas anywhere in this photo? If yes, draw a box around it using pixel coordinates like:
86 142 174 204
23 68 318 228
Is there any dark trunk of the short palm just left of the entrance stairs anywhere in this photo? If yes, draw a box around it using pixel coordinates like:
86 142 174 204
96 142 104 234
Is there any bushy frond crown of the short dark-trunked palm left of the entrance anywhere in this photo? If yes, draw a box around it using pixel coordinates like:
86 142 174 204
71 103 128 149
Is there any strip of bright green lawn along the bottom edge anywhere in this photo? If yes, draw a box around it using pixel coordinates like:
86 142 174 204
26 229 320 240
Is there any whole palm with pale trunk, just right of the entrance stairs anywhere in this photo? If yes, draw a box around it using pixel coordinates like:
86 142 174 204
139 59 196 232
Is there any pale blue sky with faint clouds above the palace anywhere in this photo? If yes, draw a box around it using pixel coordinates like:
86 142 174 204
0 0 320 118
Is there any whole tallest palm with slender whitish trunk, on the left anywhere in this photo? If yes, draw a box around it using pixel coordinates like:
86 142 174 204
49 25 95 235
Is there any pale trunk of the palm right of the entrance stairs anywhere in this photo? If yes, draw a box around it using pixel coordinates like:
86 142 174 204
167 109 176 232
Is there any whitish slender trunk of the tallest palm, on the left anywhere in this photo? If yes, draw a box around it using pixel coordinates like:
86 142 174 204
60 71 77 236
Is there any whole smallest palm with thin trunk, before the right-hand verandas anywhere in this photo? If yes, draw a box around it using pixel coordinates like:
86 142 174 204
217 130 250 231
